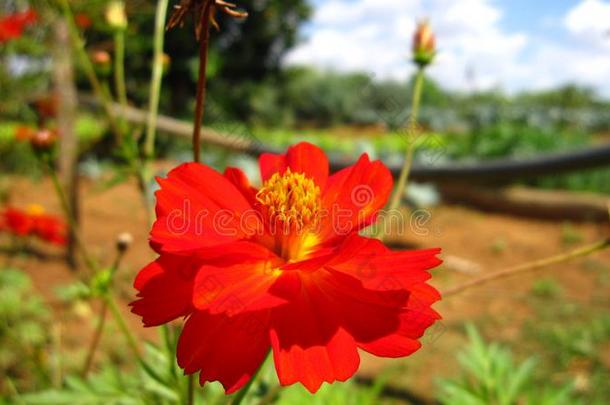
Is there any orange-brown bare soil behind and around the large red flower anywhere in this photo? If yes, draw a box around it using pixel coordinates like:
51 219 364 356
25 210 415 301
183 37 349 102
0 173 610 398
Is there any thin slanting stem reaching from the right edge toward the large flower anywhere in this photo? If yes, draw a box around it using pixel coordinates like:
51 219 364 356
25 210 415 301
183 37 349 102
442 239 610 297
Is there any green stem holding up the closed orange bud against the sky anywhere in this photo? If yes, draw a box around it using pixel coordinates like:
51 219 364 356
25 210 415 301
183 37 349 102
389 68 424 211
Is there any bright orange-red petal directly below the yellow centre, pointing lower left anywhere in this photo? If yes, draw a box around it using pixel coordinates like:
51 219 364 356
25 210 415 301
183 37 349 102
193 246 286 316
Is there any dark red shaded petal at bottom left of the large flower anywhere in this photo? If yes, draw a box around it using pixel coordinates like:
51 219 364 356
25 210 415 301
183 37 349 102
177 311 269 394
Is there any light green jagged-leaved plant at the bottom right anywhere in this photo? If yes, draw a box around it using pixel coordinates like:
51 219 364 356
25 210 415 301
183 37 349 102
439 325 575 405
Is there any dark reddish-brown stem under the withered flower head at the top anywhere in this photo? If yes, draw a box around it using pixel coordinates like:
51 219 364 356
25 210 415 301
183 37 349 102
193 1 214 162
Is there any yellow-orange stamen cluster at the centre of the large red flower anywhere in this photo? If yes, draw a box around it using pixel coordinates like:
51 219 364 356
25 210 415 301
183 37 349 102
256 169 321 233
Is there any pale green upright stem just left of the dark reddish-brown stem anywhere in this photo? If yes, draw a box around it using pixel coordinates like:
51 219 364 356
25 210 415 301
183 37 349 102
144 0 169 161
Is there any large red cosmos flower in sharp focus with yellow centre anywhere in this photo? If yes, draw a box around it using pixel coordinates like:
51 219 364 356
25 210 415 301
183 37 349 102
131 143 440 394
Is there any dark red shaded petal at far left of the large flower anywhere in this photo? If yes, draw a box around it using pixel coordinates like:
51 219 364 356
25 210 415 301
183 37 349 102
130 255 199 326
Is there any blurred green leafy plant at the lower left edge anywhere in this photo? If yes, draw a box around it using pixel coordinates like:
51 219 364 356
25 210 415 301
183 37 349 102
0 268 50 395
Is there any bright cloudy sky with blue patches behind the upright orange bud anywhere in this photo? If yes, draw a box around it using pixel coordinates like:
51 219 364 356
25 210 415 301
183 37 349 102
286 0 610 95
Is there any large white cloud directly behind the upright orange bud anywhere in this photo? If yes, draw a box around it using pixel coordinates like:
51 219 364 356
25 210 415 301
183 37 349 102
287 0 527 89
